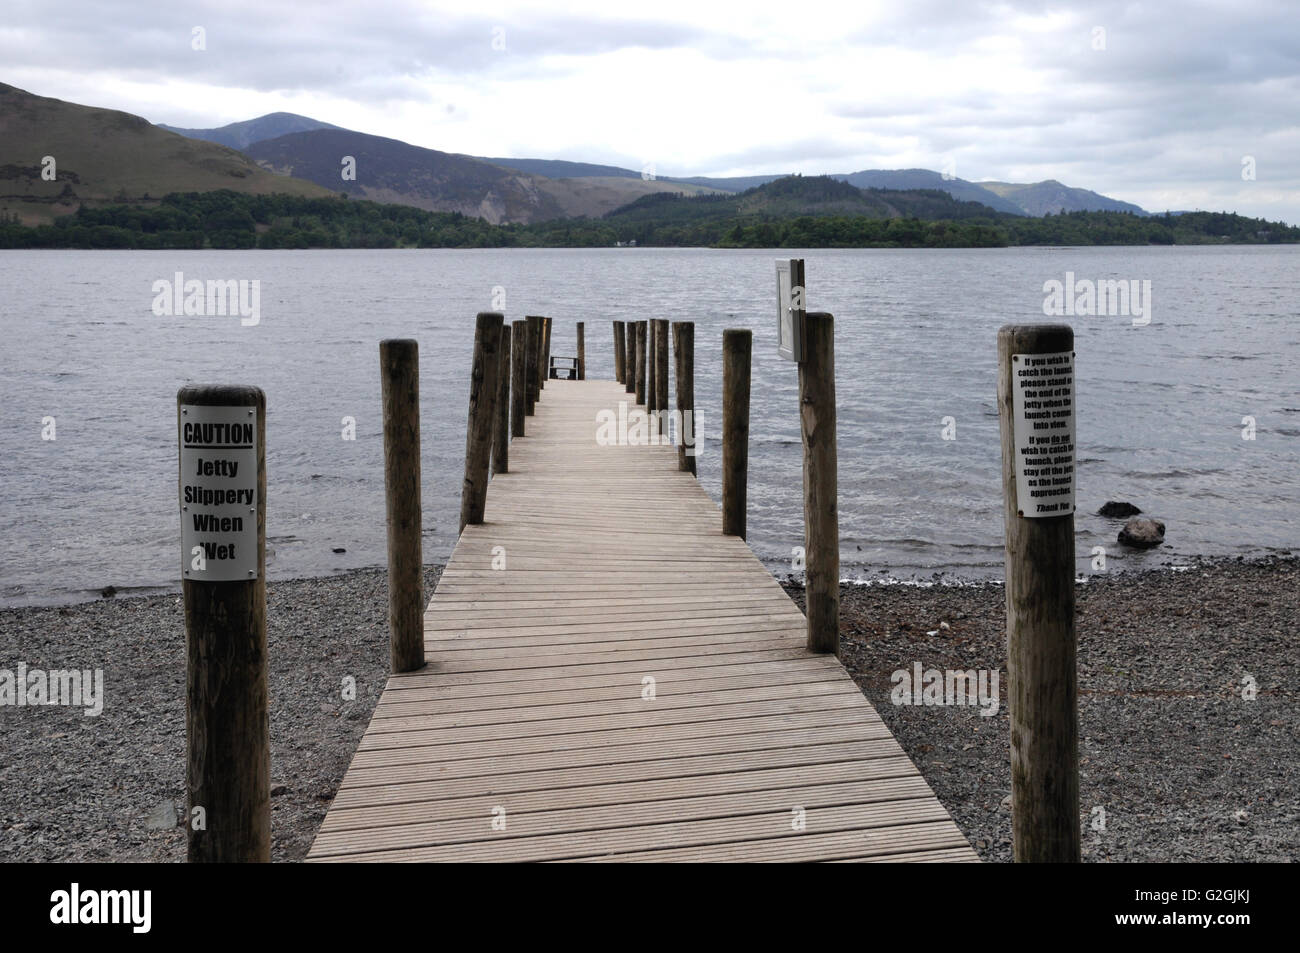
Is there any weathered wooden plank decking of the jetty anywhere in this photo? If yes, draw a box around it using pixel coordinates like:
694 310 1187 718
308 381 976 861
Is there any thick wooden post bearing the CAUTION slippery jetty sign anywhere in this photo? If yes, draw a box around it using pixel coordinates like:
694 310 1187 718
176 386 270 863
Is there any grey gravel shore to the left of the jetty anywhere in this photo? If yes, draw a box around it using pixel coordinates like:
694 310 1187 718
0 567 441 861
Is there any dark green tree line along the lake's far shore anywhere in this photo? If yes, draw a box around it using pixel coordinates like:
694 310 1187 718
0 191 1300 248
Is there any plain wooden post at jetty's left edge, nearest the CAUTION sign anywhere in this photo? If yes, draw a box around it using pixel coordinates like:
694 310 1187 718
380 338 424 672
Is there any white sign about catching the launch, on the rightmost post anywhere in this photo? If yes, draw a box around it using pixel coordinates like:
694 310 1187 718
1011 351 1075 517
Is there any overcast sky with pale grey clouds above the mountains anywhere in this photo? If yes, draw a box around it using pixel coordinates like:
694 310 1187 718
0 0 1300 224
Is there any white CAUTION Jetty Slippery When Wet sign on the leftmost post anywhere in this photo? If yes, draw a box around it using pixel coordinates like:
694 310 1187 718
179 404 257 582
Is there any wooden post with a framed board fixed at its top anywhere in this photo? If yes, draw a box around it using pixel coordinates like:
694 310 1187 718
800 311 840 654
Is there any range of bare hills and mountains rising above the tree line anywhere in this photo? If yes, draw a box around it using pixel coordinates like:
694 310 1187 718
0 85 1147 224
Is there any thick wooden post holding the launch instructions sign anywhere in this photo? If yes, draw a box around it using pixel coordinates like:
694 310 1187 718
997 324 1082 863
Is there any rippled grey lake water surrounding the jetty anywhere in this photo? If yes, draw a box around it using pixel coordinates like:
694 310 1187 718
0 247 1300 605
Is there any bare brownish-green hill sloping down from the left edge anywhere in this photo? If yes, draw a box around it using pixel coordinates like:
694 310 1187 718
0 83 326 224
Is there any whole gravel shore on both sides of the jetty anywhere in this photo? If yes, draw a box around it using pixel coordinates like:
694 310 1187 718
0 559 1300 861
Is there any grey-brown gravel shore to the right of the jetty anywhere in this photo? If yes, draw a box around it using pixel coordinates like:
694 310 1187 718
787 558 1300 862
